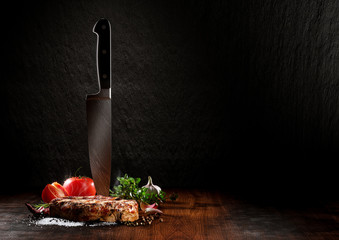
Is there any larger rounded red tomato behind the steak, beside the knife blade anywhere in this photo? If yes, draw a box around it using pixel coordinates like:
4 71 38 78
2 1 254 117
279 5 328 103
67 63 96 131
63 177 96 196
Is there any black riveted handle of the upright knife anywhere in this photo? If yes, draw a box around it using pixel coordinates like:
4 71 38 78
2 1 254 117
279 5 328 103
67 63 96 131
93 18 111 89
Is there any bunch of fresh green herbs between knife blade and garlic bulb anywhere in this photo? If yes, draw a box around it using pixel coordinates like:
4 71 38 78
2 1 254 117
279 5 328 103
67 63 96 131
109 174 178 204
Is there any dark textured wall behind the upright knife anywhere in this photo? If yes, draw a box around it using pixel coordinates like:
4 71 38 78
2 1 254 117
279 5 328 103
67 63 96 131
1 0 339 199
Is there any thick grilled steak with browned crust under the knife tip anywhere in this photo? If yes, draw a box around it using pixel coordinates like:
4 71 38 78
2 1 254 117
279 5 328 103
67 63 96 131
50 195 139 222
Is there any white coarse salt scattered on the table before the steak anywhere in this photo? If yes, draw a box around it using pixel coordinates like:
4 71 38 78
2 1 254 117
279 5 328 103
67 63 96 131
32 217 117 227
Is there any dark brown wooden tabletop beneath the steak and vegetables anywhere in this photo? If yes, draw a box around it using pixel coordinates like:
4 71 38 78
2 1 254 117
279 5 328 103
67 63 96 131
0 190 339 240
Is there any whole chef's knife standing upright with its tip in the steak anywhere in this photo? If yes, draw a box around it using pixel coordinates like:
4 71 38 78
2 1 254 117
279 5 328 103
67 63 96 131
86 19 112 196
